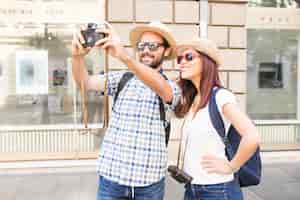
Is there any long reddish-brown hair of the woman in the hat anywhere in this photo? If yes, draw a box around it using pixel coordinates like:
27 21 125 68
175 52 223 118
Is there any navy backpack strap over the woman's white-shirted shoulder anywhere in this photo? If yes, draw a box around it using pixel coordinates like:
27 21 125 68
208 87 228 146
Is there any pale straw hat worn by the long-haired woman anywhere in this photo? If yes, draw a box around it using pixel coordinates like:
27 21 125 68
176 37 222 66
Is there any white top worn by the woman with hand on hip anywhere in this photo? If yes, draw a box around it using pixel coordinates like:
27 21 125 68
182 89 236 185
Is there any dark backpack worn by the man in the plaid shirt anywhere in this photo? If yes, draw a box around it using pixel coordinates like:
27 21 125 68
113 72 171 146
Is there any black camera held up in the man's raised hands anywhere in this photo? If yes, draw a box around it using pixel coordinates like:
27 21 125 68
81 23 107 48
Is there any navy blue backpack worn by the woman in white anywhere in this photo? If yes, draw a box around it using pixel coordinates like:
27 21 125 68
208 88 262 187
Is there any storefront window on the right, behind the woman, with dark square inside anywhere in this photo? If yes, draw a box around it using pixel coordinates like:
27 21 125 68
247 29 300 120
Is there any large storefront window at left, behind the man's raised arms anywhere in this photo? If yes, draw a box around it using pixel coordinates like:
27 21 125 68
0 24 105 126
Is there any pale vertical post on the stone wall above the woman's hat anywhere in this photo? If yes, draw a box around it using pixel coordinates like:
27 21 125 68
199 0 209 38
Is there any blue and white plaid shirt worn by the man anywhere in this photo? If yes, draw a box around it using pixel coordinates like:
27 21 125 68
98 72 181 187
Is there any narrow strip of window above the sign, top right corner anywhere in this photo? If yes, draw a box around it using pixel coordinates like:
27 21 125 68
248 0 300 8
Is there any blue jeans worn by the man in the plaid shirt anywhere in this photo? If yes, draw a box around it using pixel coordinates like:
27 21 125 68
97 176 165 200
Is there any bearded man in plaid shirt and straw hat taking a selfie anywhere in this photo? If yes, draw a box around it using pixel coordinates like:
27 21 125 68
72 22 181 200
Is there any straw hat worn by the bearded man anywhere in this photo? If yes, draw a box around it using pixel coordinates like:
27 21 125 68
129 25 176 60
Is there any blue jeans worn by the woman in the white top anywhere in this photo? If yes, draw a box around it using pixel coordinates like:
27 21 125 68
184 180 243 200
